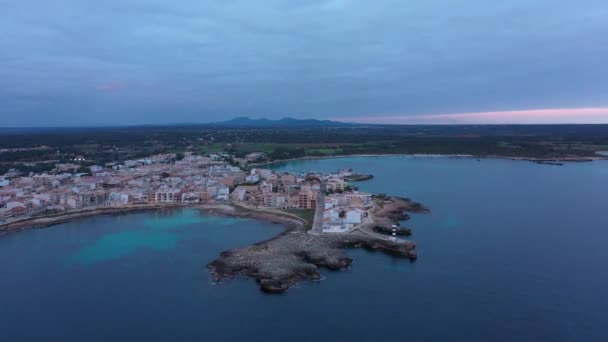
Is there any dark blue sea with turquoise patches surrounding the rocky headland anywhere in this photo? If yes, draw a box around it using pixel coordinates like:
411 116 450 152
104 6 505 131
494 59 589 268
0 157 608 341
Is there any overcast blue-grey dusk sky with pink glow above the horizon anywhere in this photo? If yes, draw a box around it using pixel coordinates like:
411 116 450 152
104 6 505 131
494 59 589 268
0 0 608 127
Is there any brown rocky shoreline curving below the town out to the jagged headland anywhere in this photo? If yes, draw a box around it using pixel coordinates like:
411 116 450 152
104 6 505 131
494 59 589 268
0 197 427 293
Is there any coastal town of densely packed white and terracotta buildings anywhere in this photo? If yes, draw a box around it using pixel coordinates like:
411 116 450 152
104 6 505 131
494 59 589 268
0 152 380 233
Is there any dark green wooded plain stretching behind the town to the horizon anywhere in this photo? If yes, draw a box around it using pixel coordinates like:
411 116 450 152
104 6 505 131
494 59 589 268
0 125 608 174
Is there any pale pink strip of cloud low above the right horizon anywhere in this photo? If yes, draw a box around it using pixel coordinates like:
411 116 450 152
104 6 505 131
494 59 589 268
336 107 608 124
